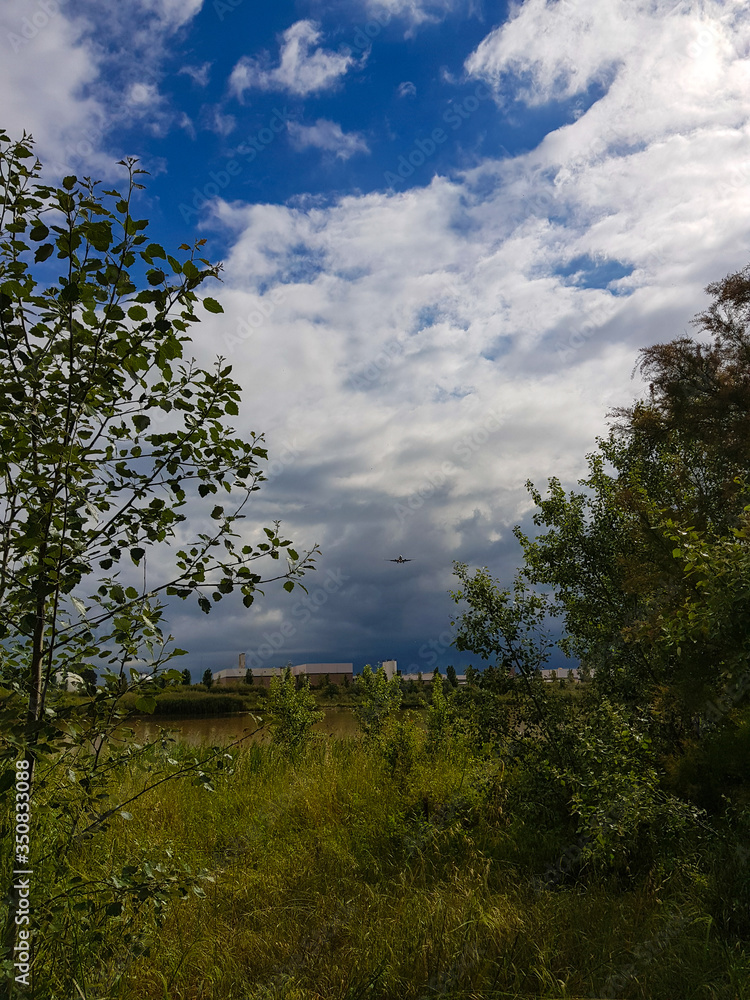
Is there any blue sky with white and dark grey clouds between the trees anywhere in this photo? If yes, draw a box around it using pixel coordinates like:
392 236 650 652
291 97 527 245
0 0 750 677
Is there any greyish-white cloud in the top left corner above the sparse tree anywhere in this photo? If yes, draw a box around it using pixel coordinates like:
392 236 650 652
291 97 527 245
0 0 210 178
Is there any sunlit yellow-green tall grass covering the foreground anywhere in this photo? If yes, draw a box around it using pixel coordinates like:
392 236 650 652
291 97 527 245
13 723 750 1000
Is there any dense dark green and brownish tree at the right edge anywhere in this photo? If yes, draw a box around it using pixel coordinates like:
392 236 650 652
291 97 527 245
459 268 750 740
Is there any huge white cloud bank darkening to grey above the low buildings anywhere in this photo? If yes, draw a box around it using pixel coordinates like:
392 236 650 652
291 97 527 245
182 0 750 669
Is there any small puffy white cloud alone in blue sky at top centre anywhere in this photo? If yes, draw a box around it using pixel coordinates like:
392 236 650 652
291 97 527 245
229 21 355 97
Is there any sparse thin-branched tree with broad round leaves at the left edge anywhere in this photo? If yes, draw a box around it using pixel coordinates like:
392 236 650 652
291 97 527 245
0 132 314 976
